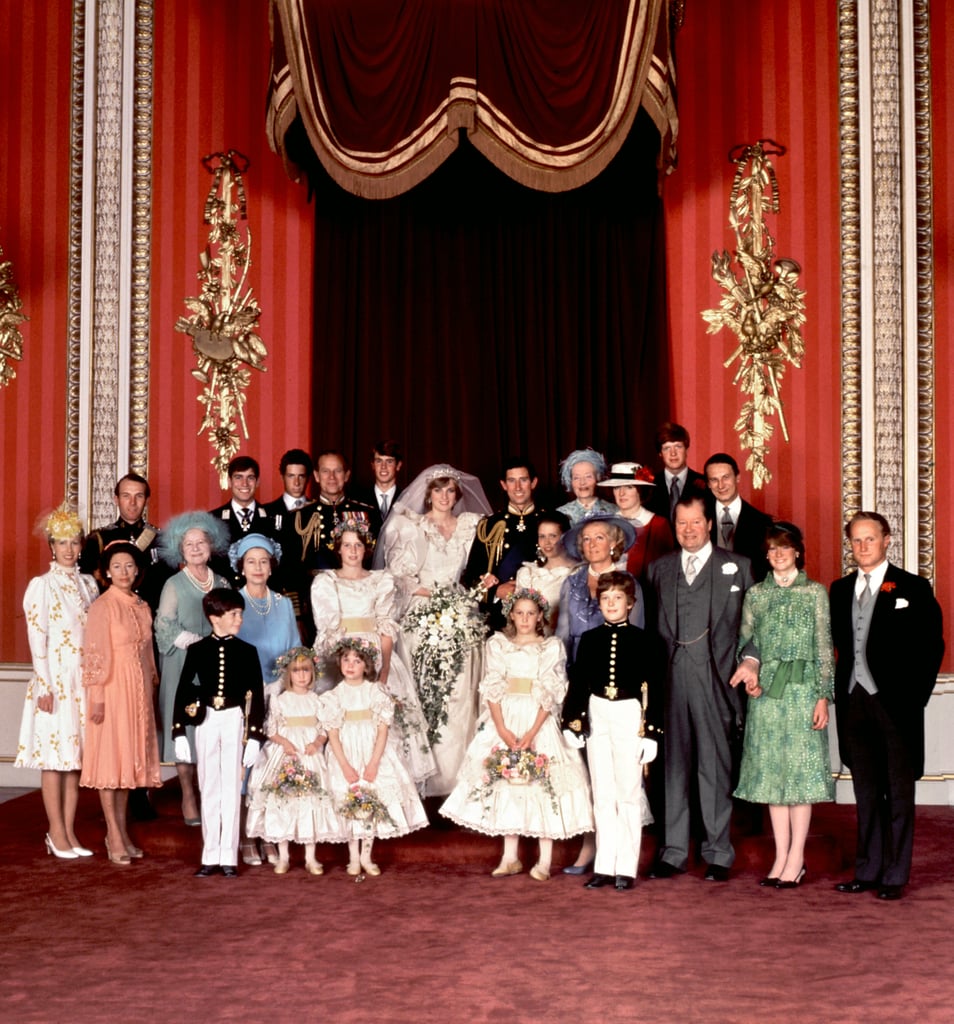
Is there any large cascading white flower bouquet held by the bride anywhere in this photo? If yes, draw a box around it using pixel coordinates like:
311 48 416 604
403 588 487 746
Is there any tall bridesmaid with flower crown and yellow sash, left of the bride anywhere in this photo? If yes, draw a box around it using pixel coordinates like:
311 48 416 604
311 513 437 783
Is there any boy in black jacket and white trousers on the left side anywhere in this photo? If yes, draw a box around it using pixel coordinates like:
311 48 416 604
172 588 265 878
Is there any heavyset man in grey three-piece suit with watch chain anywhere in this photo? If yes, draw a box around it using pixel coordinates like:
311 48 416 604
648 495 758 882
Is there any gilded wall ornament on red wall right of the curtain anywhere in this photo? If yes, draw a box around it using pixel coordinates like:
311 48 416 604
702 139 805 487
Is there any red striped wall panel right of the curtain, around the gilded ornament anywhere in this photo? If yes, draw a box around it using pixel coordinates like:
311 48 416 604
664 0 841 598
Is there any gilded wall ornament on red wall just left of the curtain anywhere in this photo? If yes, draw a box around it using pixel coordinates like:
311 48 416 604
176 150 268 489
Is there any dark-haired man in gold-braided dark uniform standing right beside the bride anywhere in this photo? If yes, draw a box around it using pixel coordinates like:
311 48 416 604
464 456 540 630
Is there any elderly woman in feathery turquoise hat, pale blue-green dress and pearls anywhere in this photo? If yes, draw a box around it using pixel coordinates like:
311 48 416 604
155 512 228 825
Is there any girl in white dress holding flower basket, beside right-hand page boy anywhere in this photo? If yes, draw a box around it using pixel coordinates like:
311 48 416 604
440 588 593 882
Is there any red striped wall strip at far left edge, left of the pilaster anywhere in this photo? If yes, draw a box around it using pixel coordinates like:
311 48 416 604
0 3 72 662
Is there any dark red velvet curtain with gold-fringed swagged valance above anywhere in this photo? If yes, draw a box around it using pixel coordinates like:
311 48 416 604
268 0 676 500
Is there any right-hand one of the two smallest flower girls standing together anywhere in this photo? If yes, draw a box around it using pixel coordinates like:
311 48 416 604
320 636 427 876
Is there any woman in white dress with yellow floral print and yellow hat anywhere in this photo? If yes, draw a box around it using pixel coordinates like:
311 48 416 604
13 506 99 860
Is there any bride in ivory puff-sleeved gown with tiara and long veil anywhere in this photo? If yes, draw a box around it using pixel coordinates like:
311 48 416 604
379 463 490 796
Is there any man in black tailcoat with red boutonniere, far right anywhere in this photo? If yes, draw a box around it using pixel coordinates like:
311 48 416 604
830 512 944 900
